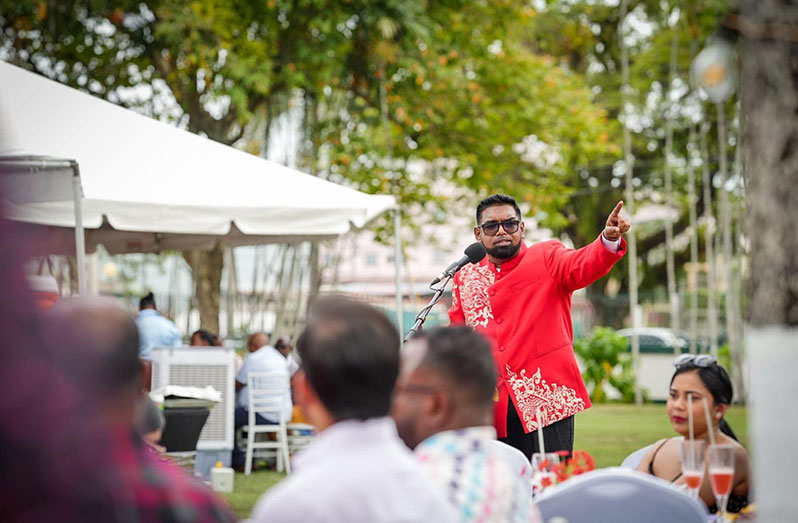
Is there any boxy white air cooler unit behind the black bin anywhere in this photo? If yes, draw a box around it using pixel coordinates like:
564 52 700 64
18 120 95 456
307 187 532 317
152 347 236 451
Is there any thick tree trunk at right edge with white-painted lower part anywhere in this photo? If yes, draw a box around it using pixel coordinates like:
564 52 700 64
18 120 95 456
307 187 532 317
740 0 798 521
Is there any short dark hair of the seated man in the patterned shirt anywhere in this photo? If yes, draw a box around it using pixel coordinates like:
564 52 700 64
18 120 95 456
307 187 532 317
413 326 496 407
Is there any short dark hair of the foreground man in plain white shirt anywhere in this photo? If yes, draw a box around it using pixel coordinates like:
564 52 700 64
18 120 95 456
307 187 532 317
296 296 400 421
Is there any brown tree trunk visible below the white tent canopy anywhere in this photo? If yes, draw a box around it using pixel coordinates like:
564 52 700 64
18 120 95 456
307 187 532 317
183 243 224 333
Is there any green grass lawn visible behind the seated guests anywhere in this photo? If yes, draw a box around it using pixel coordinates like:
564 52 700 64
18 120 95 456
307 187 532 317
220 404 748 519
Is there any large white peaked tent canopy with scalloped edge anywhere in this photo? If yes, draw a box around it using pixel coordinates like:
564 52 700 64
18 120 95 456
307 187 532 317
0 62 395 253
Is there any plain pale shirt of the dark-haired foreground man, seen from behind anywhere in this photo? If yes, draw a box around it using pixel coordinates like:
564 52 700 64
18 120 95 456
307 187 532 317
252 417 456 523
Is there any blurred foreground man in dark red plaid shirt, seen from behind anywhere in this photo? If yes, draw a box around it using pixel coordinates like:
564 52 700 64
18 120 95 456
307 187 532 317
43 298 235 522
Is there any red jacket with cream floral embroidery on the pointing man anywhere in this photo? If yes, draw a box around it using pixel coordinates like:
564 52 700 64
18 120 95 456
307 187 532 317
449 236 626 437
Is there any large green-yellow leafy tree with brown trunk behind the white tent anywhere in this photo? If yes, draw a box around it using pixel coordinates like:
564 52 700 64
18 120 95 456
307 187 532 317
0 0 617 329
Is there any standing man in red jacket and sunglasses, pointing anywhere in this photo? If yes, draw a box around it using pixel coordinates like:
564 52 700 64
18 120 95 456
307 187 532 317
449 194 631 457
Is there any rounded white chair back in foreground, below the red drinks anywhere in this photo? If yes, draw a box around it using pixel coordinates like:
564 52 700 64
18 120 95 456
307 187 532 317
536 467 708 523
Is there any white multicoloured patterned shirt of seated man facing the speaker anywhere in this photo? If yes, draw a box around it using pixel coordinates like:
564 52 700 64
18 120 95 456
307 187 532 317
415 426 541 523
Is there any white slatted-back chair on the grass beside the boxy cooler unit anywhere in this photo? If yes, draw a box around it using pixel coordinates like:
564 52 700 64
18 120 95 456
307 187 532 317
242 372 291 475
